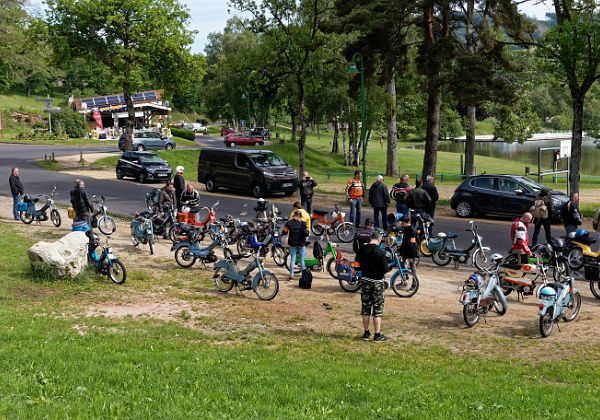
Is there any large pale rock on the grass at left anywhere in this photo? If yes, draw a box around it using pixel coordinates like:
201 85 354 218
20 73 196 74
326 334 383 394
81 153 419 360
27 232 88 279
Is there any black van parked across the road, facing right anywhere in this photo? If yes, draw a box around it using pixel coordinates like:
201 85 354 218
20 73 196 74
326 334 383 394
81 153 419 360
198 147 298 197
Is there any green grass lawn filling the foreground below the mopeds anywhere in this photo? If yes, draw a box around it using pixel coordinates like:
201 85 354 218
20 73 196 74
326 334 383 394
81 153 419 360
0 222 600 419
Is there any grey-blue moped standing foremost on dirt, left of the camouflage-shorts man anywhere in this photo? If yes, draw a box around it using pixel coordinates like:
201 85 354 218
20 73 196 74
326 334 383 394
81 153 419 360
213 236 279 300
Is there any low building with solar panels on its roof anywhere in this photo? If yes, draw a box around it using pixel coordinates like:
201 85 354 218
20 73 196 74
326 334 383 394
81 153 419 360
71 90 171 133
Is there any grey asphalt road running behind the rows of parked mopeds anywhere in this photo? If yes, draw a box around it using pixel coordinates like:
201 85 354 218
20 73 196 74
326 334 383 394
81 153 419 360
0 139 516 254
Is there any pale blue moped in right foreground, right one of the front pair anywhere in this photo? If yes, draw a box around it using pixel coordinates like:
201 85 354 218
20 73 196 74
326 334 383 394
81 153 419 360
538 276 581 338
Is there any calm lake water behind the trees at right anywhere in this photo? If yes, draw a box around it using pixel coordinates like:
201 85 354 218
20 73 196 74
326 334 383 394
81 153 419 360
418 138 600 175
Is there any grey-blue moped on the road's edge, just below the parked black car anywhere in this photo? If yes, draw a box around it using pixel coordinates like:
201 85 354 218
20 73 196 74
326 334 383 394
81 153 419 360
429 220 494 270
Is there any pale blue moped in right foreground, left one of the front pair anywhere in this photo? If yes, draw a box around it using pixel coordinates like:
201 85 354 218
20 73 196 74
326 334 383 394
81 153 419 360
459 254 508 327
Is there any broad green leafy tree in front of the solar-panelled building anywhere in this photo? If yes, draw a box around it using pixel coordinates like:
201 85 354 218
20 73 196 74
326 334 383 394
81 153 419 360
48 0 194 150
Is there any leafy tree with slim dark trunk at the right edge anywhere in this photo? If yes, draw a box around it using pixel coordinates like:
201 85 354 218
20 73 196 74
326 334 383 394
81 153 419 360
539 0 600 192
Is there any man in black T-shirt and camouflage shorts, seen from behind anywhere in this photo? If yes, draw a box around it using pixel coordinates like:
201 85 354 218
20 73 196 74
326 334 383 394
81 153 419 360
356 229 388 342
